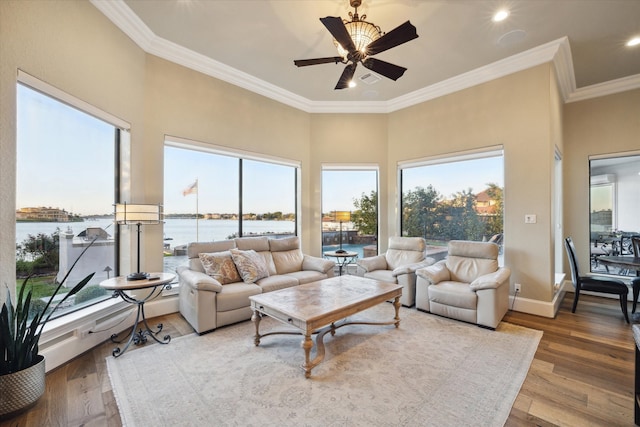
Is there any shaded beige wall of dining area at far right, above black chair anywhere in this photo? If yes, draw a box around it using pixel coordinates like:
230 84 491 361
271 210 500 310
563 89 640 273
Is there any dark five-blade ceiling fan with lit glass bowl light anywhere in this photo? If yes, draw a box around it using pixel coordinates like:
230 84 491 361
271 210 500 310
293 0 418 89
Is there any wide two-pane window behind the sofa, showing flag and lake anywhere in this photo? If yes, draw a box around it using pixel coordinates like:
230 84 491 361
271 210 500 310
164 138 300 272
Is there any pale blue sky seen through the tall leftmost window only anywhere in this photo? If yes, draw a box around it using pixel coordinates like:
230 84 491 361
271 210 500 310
16 85 114 215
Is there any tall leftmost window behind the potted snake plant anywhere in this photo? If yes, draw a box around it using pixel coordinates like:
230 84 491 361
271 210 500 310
16 78 121 316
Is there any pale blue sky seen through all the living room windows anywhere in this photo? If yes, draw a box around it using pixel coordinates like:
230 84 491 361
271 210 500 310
16 85 503 215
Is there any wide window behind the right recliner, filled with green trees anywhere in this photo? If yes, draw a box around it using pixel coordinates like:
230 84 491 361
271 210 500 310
399 148 504 258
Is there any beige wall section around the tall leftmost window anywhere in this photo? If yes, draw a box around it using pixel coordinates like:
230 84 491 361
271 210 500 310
0 0 146 299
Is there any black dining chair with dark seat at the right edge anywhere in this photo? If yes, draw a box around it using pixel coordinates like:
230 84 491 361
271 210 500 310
564 237 629 323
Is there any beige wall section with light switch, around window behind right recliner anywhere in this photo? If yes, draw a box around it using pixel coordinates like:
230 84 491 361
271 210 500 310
387 64 555 302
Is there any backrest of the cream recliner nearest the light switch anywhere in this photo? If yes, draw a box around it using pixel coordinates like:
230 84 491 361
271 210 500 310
445 240 499 283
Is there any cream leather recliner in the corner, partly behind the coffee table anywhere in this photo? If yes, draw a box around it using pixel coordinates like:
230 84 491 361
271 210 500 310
356 237 435 307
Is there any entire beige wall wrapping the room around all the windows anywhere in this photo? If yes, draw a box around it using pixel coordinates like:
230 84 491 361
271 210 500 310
0 0 640 314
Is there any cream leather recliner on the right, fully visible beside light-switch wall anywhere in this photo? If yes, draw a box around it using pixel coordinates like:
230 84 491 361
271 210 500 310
416 240 511 329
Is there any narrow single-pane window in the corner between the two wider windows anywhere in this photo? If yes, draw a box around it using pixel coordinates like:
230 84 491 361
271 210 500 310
322 169 378 258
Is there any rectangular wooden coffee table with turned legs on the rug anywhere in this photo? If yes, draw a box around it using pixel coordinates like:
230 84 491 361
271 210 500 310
249 276 402 378
